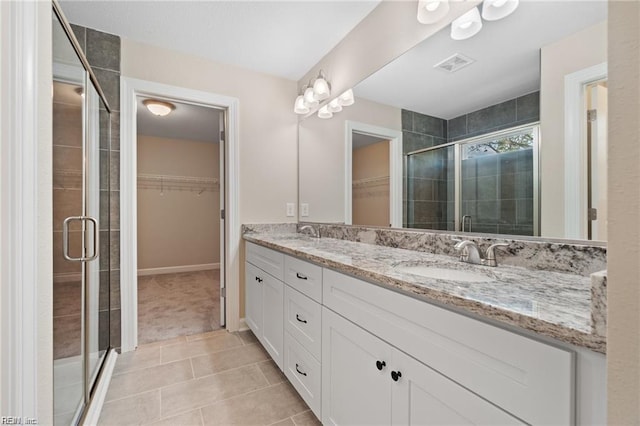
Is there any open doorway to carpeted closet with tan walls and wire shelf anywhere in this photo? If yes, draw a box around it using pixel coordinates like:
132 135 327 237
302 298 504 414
136 96 225 344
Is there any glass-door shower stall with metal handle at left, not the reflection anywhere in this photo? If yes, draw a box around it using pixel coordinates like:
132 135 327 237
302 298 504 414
52 2 115 425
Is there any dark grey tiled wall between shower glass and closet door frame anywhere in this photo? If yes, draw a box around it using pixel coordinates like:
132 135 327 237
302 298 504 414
71 24 121 348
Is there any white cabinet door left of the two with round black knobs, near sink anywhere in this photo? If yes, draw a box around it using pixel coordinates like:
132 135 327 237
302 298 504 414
322 308 392 425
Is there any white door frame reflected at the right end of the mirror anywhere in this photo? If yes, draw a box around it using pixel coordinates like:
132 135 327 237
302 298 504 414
564 62 607 240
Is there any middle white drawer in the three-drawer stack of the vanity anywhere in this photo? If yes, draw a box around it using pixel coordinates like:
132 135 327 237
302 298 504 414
284 285 322 360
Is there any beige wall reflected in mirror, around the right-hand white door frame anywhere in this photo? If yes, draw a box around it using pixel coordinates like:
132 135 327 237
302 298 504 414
540 21 607 238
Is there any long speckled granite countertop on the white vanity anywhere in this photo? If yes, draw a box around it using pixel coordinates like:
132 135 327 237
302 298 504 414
244 233 606 353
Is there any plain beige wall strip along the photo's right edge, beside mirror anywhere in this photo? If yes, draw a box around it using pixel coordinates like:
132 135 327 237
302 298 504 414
607 1 640 425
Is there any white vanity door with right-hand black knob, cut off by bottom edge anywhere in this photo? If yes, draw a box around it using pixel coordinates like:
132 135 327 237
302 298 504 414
389 349 523 426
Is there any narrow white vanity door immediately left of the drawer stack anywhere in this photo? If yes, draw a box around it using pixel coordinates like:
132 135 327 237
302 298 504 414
260 274 284 370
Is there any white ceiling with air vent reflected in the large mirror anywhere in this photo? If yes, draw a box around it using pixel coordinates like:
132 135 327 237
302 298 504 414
354 0 607 119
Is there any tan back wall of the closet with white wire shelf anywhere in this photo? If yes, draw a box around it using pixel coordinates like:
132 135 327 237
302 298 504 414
137 135 220 270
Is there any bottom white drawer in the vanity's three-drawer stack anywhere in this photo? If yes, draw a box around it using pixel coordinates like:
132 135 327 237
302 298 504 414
284 332 322 419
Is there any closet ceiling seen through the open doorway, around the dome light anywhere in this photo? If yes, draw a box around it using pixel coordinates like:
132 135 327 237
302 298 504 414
137 97 221 143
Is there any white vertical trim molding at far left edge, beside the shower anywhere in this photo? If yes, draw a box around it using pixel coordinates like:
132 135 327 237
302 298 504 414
0 1 53 424
